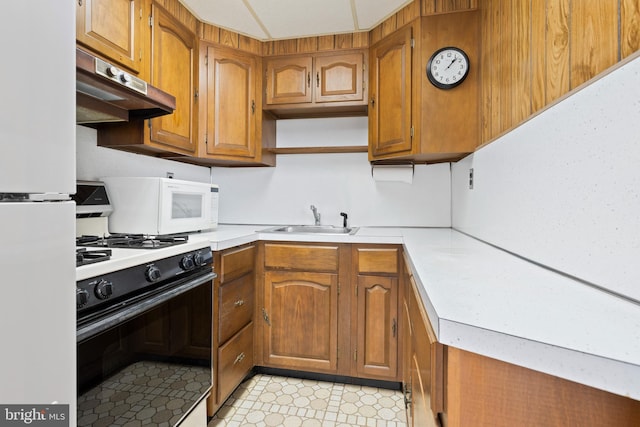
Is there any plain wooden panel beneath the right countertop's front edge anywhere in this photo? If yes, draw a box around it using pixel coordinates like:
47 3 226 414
445 347 640 427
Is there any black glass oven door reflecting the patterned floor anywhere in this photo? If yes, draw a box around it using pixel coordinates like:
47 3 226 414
77 272 215 426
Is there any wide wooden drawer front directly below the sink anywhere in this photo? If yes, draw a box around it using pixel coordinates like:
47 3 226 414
264 243 340 271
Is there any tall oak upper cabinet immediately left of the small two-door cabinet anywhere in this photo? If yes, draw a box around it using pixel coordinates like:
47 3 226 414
198 42 275 166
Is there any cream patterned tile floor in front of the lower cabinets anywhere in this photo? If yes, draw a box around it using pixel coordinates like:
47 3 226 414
209 375 406 427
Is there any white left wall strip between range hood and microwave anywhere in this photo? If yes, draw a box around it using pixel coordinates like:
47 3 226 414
76 126 210 182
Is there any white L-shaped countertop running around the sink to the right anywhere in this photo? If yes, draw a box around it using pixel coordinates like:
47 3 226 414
77 225 640 400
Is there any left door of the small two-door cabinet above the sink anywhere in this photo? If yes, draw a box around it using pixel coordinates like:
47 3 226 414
265 56 313 105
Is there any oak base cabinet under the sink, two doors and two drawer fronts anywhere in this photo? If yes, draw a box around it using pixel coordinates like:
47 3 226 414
257 242 401 381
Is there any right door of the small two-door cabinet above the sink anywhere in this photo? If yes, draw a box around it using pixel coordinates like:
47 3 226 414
314 53 364 102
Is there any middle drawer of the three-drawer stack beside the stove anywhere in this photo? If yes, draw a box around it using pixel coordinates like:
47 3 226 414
218 274 255 343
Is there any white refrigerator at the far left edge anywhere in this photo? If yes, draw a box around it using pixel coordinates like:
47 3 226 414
0 0 76 426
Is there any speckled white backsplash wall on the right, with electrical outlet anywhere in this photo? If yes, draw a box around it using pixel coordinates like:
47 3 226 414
452 55 640 300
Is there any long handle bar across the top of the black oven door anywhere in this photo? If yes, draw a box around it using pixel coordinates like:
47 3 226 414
76 272 217 342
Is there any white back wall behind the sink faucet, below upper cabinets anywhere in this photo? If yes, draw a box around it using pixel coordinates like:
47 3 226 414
212 117 451 227
